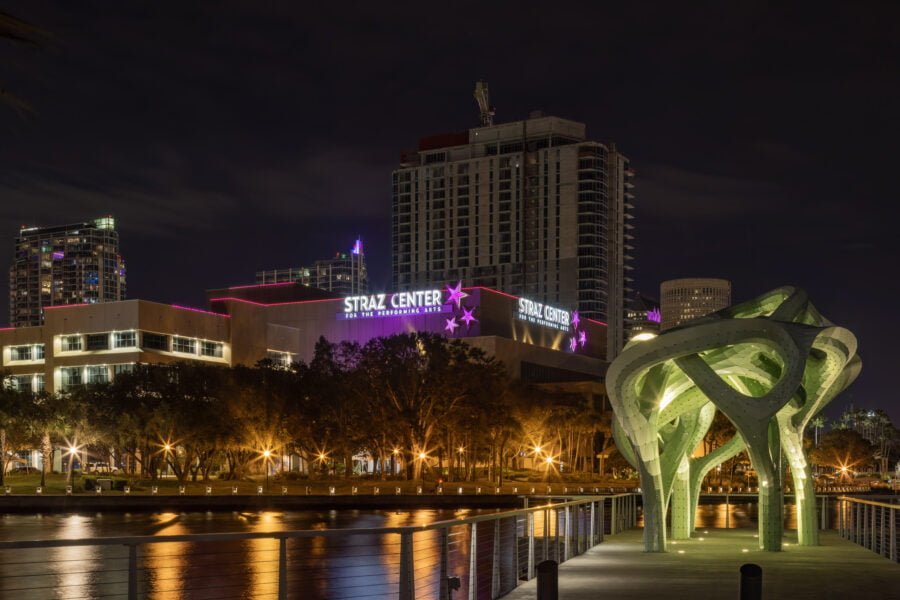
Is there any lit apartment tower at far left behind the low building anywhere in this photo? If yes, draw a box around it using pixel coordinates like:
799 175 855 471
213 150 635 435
9 216 125 327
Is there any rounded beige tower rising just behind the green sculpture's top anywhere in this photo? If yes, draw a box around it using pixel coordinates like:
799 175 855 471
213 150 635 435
659 278 731 331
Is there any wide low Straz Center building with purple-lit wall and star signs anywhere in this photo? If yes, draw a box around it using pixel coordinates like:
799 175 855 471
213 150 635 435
0 283 607 400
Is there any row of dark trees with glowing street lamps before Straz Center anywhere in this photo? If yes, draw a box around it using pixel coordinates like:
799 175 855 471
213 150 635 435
0 334 611 483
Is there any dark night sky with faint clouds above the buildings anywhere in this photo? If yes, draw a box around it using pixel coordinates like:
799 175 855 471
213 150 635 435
0 0 900 424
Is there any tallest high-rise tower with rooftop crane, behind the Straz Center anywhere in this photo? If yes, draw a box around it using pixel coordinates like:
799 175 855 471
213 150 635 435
392 114 634 359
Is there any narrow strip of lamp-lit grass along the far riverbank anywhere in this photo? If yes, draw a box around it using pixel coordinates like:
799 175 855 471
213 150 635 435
5 473 637 496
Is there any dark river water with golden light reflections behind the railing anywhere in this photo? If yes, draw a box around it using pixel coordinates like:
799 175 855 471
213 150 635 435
0 501 836 600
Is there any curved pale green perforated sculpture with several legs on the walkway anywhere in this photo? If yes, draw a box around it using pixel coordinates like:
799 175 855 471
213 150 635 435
606 287 862 552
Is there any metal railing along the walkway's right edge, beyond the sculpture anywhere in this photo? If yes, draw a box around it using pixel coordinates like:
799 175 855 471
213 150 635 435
837 496 900 562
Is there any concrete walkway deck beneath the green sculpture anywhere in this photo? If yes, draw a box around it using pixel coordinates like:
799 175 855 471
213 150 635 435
504 529 900 600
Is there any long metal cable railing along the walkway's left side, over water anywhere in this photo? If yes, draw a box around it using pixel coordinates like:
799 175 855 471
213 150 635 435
0 494 637 600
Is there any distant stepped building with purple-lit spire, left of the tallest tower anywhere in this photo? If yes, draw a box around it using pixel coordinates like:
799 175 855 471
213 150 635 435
256 239 369 296
